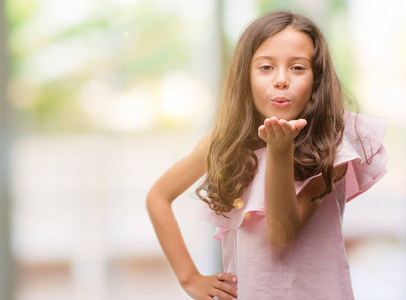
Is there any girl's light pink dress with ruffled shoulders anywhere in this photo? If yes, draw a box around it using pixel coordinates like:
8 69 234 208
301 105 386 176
196 112 386 300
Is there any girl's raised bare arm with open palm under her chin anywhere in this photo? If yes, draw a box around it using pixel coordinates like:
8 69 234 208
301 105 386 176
259 117 346 248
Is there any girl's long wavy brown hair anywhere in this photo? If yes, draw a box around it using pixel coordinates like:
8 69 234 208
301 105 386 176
196 12 344 215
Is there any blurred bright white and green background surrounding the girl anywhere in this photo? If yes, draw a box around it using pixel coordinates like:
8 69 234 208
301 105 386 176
0 0 406 300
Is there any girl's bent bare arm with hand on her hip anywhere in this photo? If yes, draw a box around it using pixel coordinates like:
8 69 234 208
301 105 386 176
147 133 236 300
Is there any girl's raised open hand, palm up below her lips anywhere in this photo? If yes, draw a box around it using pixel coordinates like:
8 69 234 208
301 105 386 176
258 117 307 151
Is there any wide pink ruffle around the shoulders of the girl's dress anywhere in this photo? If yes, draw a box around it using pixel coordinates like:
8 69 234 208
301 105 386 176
195 111 386 240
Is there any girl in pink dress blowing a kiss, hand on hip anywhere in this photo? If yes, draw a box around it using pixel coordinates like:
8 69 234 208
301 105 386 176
147 12 386 300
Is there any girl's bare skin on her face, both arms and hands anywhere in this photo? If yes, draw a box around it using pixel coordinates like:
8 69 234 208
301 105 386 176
147 25 345 300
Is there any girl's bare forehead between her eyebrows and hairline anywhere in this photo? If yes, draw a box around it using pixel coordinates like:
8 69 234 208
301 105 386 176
253 27 314 60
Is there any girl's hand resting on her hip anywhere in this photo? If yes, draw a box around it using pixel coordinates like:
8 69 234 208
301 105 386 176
182 273 237 300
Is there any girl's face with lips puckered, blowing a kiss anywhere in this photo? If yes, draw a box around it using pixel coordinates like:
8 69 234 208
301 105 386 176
251 27 314 122
